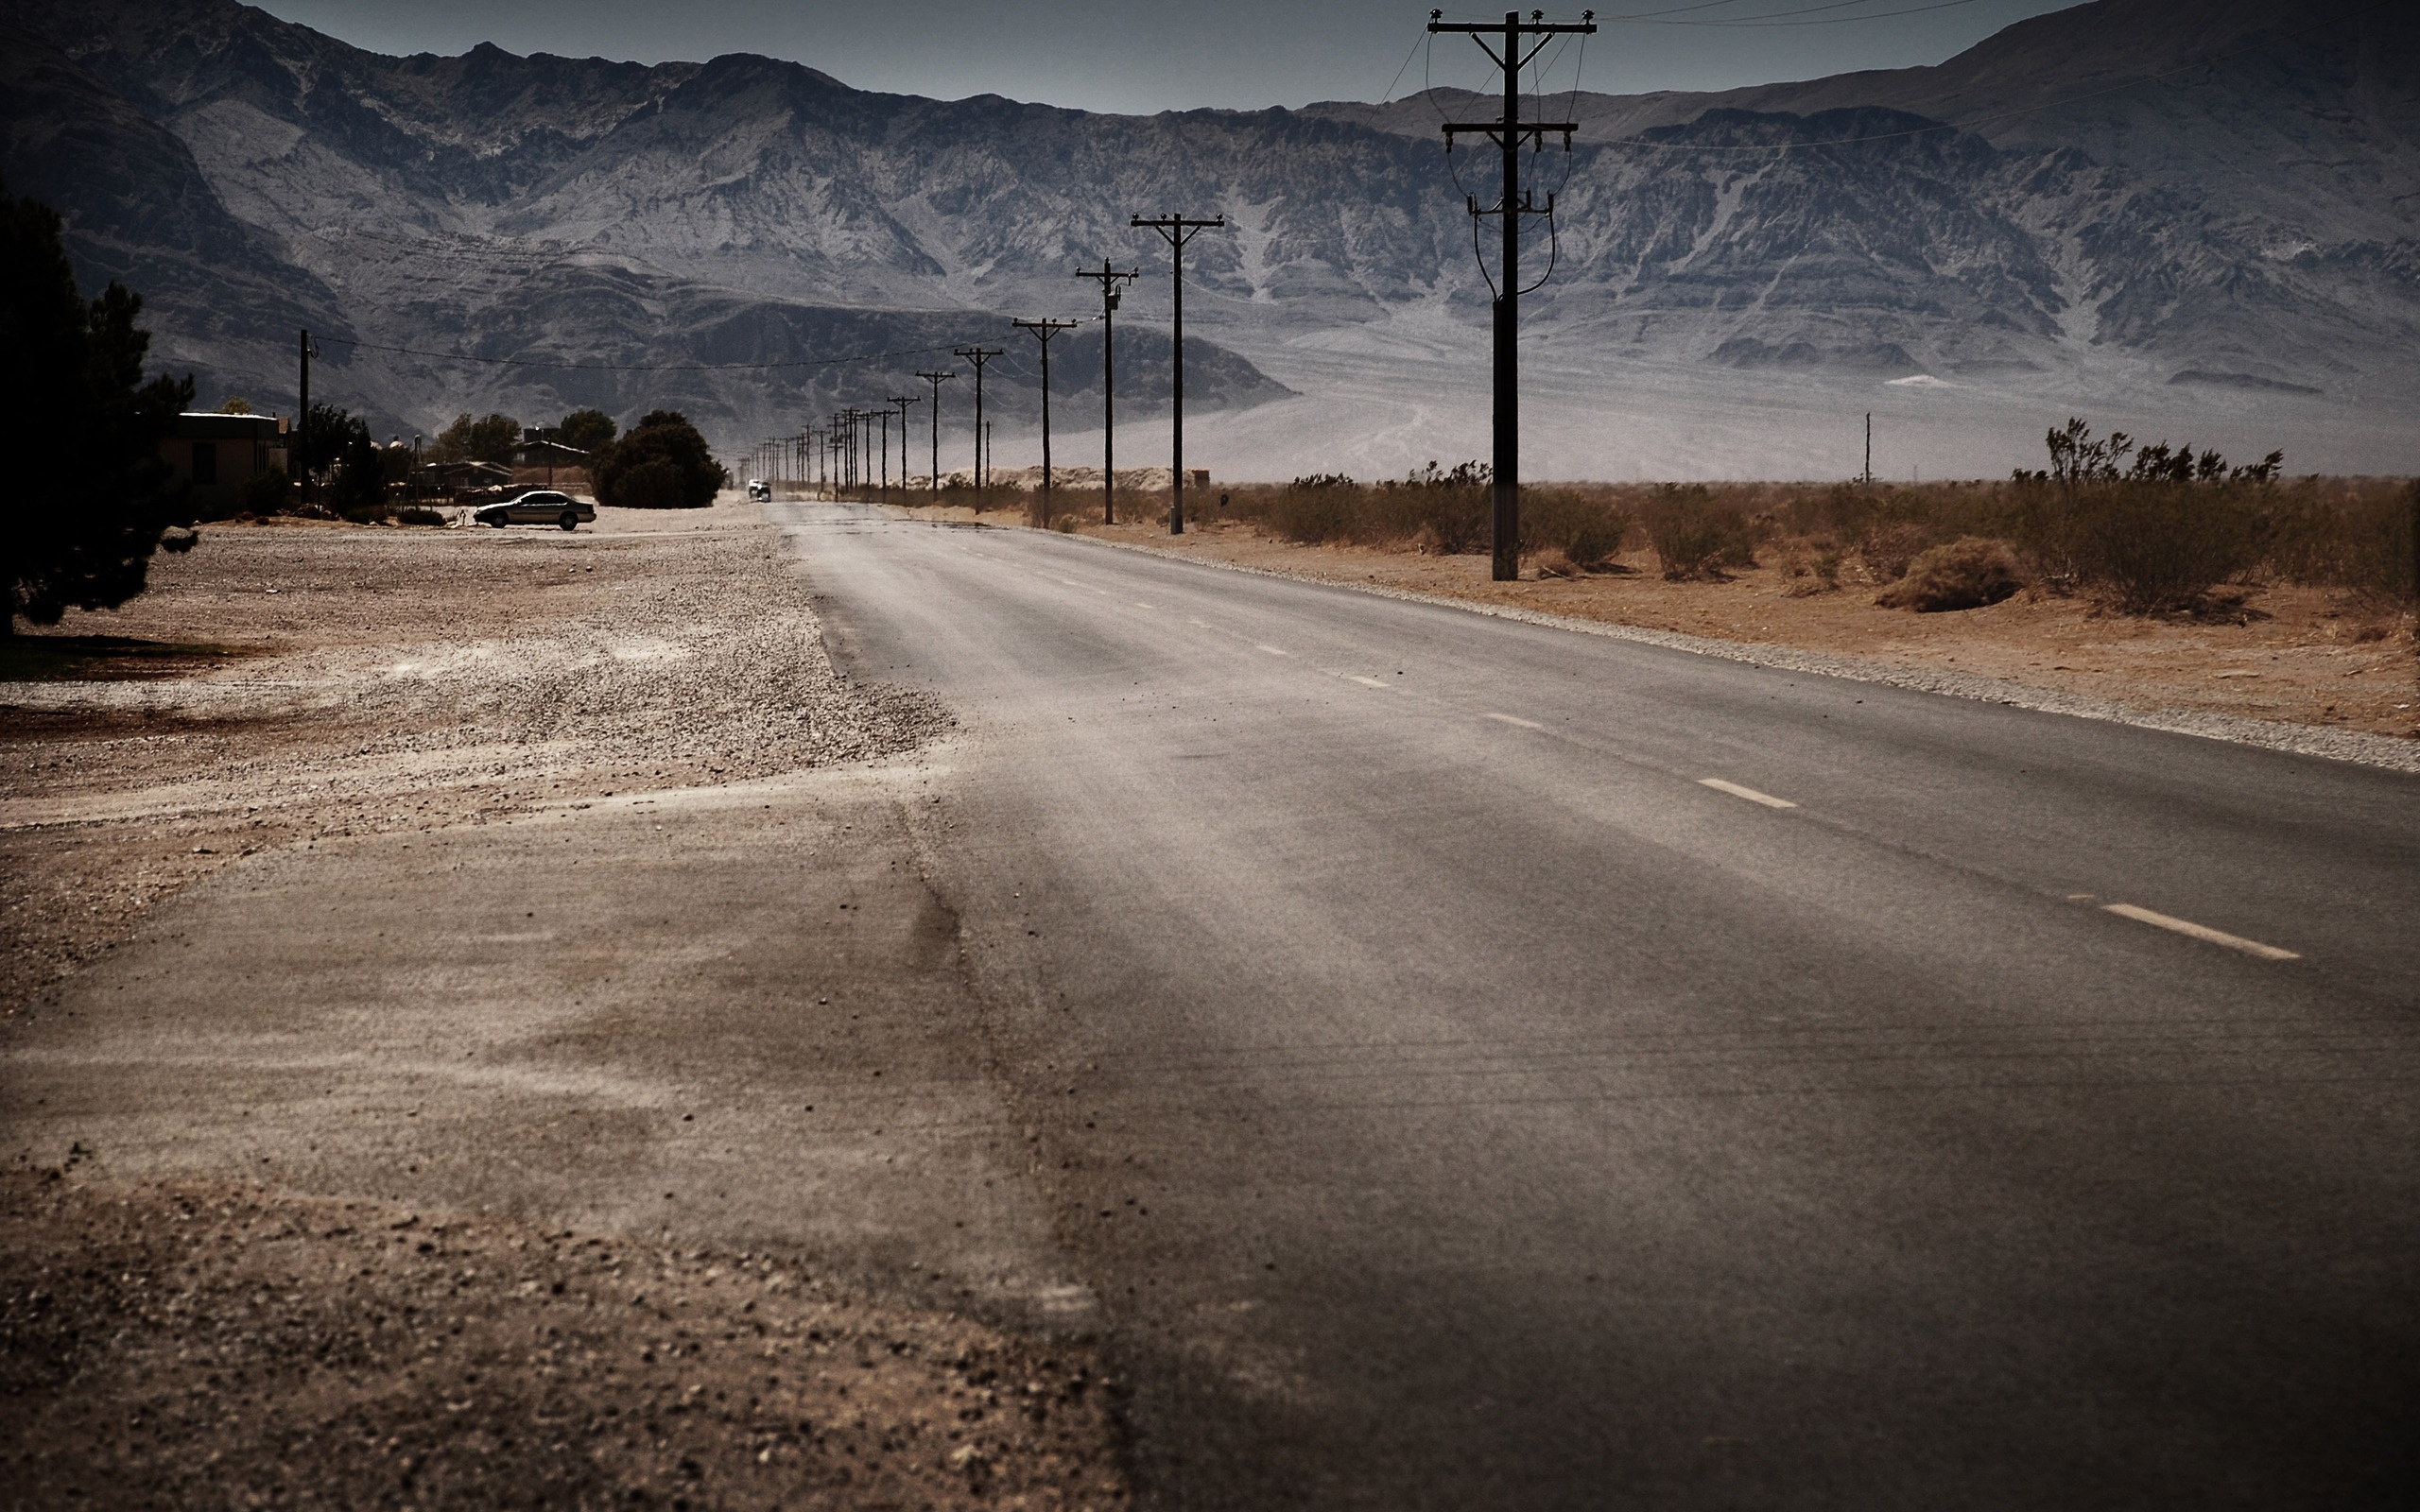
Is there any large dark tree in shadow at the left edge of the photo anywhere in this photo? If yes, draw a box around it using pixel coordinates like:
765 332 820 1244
0 184 196 634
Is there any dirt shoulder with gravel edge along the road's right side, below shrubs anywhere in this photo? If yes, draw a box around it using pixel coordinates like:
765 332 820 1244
912 508 2420 772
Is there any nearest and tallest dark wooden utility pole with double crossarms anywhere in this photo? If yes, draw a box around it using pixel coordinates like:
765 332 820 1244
1427 9 1598 583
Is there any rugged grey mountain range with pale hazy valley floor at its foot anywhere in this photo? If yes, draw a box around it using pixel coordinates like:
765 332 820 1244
0 0 2420 476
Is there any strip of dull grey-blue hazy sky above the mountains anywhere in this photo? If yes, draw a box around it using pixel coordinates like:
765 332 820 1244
261 0 2071 113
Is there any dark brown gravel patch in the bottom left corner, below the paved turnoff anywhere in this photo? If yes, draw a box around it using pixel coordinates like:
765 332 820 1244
0 1168 1125 1507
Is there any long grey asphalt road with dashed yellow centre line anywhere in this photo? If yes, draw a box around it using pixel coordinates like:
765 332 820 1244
774 506 2420 1509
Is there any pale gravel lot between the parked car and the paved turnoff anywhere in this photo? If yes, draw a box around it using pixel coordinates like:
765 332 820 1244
0 503 943 1014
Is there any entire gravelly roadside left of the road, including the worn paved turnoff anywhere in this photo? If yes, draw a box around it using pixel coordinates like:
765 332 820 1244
0 503 1128 1509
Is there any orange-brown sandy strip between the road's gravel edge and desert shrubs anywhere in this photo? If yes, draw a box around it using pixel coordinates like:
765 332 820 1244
890 503 2420 740
